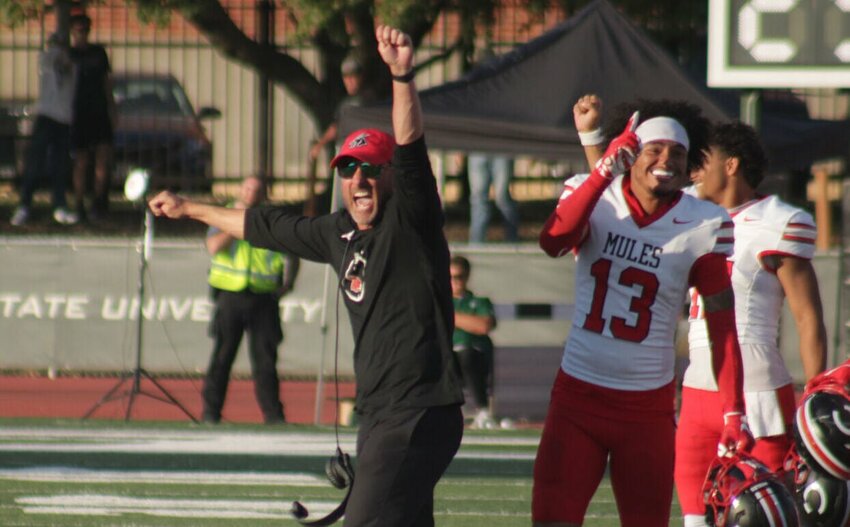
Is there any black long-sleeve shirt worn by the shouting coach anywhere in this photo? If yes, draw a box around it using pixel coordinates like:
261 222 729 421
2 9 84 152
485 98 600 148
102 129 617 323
245 138 463 414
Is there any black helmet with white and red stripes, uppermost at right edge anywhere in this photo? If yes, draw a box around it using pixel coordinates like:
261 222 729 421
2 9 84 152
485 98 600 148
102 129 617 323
794 384 850 480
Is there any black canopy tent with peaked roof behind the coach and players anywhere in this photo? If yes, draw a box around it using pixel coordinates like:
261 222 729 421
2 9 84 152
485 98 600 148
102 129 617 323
341 0 850 170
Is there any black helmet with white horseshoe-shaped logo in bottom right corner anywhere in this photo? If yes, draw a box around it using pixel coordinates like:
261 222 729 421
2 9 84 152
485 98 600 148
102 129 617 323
783 446 850 527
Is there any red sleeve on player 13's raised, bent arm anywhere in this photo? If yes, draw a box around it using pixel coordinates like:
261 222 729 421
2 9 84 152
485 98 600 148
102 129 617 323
540 170 611 258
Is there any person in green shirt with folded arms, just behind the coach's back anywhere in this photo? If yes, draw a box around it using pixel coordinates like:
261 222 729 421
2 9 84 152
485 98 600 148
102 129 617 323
449 256 496 428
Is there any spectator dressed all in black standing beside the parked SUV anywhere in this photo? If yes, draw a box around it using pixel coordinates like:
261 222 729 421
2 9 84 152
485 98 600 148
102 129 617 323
71 14 116 220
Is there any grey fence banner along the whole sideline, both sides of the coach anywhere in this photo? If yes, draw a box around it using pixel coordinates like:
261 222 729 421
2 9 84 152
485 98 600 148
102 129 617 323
0 236 845 384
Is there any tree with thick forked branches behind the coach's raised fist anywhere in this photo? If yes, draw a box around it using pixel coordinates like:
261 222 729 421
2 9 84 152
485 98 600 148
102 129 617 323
0 0 498 129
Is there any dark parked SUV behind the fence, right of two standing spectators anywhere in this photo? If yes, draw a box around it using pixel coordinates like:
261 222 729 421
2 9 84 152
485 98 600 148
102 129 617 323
113 73 221 191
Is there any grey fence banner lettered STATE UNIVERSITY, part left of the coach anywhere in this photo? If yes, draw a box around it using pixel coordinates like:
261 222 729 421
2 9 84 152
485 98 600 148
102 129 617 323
0 238 338 375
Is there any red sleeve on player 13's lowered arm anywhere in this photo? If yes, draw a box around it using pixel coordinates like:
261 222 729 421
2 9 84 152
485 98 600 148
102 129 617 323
691 253 745 414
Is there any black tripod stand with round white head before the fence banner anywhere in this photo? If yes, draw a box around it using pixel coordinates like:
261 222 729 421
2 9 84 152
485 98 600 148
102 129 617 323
83 169 198 423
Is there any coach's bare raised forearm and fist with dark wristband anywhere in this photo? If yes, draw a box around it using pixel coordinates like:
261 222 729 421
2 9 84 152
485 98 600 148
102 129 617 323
375 25 423 145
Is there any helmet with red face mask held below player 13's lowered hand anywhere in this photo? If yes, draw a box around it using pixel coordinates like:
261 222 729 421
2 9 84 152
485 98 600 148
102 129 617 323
703 453 800 527
